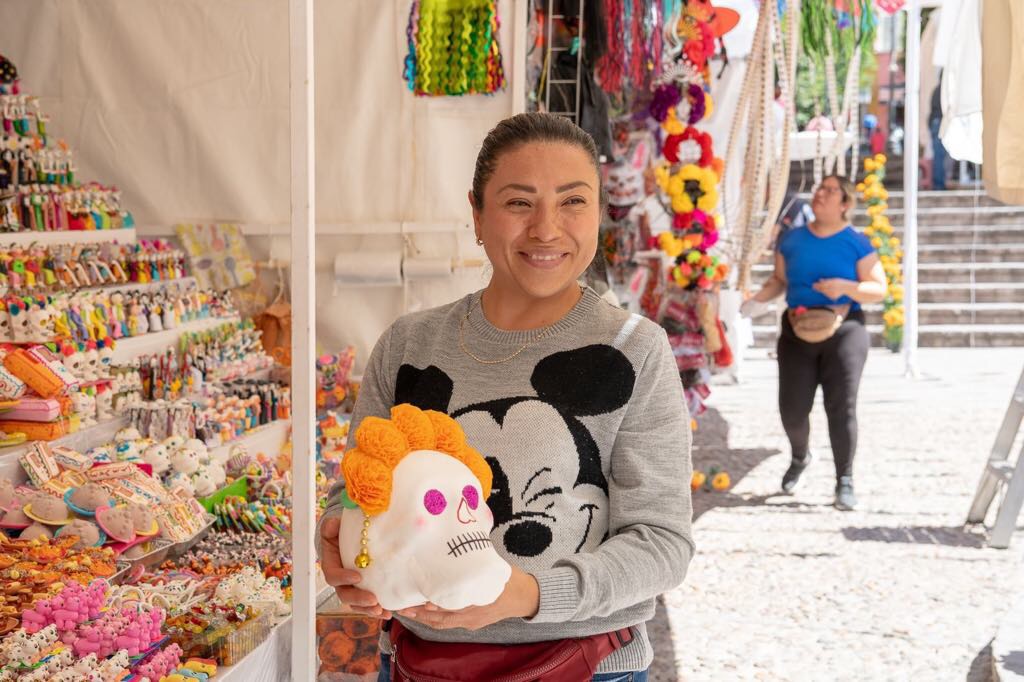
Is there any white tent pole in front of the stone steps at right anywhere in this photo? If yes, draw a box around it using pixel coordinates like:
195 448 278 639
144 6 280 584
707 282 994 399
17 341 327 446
903 0 921 377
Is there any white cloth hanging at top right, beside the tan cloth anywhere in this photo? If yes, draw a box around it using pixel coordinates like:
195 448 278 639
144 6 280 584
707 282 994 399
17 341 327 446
935 0 984 164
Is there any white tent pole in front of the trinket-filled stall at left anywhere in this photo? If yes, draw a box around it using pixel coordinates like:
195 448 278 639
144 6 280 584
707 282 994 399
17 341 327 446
289 0 316 680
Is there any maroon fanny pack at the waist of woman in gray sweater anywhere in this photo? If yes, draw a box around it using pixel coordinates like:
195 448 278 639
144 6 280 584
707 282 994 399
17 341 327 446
388 620 633 682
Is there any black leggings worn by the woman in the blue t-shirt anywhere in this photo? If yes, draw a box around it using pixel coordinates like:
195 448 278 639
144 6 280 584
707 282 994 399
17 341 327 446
778 310 870 478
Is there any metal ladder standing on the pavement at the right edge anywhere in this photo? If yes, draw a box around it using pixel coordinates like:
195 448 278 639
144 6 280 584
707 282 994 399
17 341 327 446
967 360 1024 549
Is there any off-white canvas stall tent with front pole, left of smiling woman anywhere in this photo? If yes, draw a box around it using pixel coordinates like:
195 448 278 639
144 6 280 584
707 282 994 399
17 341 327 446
0 0 526 680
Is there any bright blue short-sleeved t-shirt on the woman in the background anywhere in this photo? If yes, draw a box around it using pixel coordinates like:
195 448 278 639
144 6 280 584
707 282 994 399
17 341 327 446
778 225 874 310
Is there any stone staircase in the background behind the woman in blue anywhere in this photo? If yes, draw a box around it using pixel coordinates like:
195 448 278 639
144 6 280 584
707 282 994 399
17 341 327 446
753 189 1024 347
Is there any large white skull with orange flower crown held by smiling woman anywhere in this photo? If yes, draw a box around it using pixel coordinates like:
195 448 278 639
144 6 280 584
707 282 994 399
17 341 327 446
338 404 512 609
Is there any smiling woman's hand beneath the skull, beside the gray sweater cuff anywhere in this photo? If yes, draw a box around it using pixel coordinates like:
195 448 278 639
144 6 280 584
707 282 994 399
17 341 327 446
397 566 541 630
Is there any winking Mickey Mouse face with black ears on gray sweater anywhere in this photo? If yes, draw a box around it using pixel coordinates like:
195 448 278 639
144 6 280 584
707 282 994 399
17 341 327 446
394 344 636 566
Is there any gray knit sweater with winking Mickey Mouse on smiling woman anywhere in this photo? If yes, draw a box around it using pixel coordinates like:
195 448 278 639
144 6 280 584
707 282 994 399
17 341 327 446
317 289 694 673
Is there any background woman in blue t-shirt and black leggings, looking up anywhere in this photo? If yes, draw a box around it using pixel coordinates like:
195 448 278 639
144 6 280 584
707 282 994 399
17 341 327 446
743 175 886 511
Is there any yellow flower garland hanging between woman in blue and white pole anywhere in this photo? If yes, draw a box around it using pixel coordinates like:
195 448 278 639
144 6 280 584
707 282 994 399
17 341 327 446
857 154 903 352
